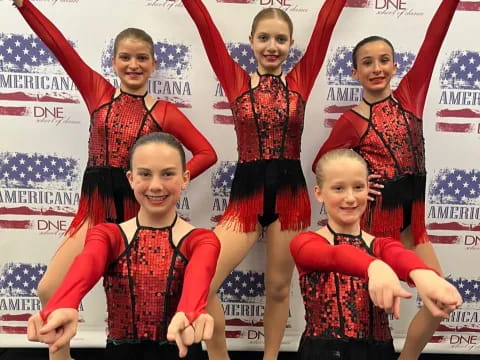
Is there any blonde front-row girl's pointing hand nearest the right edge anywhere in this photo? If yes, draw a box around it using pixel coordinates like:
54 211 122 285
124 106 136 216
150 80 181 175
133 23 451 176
409 269 462 319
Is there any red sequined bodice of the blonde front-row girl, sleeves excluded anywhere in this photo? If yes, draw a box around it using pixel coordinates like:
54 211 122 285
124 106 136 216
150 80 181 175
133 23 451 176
300 234 391 341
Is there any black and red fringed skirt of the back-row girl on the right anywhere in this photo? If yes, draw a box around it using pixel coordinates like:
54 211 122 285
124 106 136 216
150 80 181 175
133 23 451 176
362 174 429 245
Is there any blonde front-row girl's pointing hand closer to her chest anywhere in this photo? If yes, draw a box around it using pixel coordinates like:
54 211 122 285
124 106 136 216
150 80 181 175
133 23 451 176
368 260 412 319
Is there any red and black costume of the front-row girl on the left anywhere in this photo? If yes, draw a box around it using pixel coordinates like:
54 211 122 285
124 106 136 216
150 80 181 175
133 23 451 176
40 218 220 358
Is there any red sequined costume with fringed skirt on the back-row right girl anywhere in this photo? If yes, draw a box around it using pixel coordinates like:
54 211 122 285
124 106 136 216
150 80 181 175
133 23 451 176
313 0 458 244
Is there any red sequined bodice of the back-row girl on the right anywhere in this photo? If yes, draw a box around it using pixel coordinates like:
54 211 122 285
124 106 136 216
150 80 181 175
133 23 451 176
356 97 425 179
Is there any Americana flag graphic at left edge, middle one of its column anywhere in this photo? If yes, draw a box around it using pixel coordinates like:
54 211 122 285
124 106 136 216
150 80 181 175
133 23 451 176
0 152 80 229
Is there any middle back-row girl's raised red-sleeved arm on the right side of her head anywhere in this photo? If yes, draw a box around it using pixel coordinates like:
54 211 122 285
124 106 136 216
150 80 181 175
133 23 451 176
288 0 346 101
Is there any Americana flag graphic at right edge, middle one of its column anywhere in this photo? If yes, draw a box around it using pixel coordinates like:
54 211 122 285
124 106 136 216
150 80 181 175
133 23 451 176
427 168 480 244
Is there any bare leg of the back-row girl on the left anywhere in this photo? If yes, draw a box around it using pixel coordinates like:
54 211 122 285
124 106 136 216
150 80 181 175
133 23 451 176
38 222 88 360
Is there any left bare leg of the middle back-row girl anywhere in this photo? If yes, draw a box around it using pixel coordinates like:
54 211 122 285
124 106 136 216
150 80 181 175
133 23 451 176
204 225 260 360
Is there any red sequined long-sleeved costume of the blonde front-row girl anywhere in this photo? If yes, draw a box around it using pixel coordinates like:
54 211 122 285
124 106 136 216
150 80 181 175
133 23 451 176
290 227 427 360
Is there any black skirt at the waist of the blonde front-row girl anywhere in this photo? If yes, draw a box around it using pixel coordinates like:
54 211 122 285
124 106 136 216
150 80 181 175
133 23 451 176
298 337 396 360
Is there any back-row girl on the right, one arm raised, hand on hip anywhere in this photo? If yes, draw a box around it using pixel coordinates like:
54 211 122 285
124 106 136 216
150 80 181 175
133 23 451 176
314 0 459 360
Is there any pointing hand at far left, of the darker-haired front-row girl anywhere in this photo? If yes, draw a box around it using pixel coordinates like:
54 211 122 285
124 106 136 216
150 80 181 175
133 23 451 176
27 308 78 353
